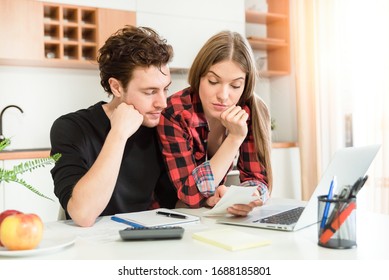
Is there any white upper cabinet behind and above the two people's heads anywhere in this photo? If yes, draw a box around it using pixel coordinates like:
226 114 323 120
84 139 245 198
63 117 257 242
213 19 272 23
136 0 245 69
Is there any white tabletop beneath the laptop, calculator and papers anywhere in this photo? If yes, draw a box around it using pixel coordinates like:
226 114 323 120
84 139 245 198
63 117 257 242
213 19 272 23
0 202 389 260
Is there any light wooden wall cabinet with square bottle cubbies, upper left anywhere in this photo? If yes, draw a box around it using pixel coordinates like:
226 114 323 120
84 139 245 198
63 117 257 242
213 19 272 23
0 0 136 69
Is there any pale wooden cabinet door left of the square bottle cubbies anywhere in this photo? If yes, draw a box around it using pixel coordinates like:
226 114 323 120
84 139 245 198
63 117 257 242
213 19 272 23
0 0 43 59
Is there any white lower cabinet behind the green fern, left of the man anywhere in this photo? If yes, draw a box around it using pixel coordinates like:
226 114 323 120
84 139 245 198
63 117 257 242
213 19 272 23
0 160 59 222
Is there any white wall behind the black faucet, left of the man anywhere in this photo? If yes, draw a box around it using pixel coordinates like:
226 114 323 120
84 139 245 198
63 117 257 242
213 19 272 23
0 66 107 149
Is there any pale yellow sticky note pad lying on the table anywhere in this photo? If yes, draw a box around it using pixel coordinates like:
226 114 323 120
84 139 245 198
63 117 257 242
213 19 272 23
192 228 270 251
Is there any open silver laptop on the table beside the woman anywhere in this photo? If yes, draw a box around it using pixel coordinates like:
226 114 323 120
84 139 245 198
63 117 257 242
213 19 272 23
217 145 380 231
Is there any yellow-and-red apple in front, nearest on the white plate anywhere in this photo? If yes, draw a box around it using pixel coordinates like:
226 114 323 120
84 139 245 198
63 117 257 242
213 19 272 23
0 213 43 250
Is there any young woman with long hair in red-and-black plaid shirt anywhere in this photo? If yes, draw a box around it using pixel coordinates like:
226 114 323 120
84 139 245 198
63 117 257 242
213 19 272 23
157 31 272 215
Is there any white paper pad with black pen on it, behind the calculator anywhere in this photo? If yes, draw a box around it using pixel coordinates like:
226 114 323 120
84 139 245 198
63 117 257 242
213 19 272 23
114 208 200 227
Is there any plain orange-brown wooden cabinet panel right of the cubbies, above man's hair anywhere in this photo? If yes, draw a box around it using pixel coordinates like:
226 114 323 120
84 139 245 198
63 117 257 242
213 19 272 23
98 8 136 47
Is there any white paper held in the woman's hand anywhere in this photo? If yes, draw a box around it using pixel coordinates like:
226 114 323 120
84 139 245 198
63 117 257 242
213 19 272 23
204 185 258 216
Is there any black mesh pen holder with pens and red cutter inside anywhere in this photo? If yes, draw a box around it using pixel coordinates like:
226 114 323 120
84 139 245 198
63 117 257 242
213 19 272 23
318 195 357 249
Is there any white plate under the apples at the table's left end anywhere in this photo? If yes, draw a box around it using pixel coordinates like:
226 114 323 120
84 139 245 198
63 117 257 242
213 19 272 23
0 235 76 257
